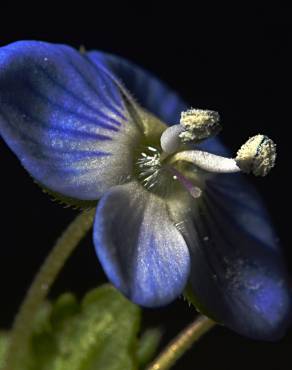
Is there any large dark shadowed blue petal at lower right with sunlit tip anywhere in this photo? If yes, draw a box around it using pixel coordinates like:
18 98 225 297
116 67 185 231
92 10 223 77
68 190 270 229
182 175 292 340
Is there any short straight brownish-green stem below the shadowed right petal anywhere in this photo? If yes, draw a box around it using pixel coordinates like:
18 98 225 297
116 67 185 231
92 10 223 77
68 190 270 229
147 316 216 370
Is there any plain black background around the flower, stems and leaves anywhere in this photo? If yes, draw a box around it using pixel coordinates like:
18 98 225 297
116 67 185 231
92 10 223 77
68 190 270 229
0 1 292 370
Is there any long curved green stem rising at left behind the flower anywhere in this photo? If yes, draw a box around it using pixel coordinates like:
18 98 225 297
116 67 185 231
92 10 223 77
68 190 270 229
3 209 95 370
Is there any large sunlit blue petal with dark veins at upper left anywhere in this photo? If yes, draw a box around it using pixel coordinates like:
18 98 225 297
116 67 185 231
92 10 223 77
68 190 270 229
0 41 140 200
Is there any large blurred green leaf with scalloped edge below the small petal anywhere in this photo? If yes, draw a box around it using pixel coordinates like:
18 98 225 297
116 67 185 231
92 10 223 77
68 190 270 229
27 285 140 370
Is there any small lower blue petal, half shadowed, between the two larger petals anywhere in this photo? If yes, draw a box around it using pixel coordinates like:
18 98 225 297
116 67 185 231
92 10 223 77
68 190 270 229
94 182 190 307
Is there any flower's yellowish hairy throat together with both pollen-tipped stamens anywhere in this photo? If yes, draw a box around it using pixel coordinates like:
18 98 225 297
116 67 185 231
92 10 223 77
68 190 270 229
134 109 276 202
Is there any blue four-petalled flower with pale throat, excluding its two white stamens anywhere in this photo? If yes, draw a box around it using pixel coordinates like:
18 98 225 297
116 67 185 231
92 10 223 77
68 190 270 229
0 41 291 340
